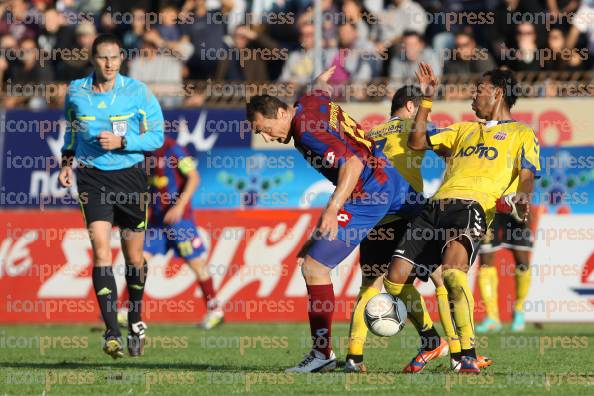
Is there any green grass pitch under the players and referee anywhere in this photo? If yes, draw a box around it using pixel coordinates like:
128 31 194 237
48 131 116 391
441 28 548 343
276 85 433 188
0 323 594 396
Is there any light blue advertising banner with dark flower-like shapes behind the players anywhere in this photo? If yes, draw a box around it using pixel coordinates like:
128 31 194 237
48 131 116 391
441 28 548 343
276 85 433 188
192 147 594 213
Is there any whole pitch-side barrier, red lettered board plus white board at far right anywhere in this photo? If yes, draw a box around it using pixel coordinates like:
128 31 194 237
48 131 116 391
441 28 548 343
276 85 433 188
0 209 594 323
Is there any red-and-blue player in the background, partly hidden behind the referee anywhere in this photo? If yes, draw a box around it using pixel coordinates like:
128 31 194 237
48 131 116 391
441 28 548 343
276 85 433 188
144 138 223 330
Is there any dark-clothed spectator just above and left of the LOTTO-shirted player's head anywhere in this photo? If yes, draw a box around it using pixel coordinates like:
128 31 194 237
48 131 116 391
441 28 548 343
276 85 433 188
443 32 495 75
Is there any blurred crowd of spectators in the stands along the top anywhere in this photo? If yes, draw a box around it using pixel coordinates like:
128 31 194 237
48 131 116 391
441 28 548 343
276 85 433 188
0 0 594 107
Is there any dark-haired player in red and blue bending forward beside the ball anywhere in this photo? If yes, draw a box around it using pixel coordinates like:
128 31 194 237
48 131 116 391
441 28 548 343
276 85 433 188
247 68 420 372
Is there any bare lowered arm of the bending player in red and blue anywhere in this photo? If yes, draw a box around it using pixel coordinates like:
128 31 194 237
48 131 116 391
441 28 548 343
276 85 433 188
318 156 363 240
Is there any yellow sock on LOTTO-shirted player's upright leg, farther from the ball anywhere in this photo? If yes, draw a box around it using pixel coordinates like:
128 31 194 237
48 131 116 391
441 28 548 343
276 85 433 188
443 269 474 349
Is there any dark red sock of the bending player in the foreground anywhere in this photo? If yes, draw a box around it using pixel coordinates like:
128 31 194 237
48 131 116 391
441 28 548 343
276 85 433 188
307 284 334 358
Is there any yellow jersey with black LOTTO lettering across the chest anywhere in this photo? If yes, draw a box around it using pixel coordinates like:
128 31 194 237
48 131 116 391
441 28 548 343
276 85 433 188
429 120 540 224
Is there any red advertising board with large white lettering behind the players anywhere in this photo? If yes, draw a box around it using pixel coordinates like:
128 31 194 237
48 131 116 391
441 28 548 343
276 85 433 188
0 209 509 323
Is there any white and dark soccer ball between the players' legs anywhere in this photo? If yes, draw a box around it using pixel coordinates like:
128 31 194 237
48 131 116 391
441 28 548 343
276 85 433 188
365 293 406 337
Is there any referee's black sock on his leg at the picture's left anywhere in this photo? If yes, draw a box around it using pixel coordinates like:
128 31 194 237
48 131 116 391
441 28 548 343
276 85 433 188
93 267 121 337
